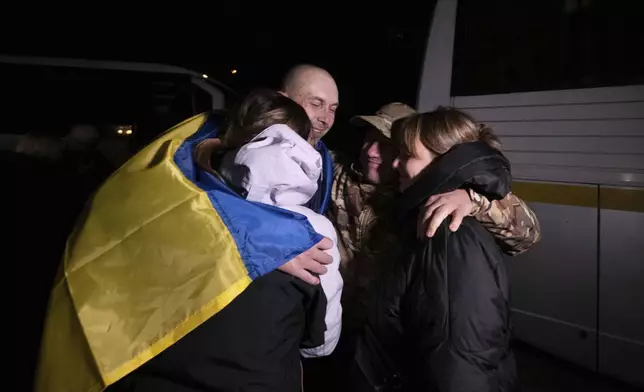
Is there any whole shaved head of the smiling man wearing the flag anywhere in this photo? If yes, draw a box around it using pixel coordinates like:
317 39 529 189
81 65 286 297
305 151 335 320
282 64 339 145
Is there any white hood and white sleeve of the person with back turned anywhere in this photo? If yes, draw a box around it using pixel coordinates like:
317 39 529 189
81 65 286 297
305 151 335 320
219 124 343 357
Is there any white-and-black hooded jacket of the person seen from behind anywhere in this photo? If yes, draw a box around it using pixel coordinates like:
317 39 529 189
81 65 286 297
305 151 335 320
108 92 342 392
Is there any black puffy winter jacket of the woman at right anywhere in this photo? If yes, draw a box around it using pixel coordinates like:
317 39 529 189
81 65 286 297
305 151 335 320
352 142 516 392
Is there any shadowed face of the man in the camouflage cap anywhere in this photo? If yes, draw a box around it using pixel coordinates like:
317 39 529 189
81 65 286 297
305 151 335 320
360 126 395 184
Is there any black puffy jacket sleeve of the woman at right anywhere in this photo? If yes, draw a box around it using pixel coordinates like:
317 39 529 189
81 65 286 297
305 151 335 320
402 222 514 392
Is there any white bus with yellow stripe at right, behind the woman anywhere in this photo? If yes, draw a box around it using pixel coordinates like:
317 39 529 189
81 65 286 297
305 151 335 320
418 0 644 386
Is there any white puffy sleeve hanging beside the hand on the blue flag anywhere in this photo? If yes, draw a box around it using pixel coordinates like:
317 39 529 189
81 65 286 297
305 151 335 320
300 214 344 358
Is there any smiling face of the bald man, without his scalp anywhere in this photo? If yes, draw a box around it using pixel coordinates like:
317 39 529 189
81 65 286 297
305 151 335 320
286 75 339 145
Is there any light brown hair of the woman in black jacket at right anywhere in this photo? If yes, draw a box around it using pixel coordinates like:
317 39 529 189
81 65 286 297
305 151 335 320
391 107 502 156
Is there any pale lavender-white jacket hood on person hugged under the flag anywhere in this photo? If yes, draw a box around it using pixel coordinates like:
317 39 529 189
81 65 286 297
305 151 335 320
219 124 322 206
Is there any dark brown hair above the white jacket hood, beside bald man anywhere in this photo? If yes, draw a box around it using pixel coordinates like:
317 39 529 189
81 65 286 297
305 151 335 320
223 89 312 148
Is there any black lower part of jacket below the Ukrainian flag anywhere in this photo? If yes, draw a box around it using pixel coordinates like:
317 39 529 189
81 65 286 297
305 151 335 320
106 271 326 392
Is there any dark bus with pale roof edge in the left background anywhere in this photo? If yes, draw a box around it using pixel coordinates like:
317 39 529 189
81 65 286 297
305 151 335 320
0 55 237 166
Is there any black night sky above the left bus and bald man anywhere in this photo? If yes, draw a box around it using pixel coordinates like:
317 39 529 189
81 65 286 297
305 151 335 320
0 4 433 152
